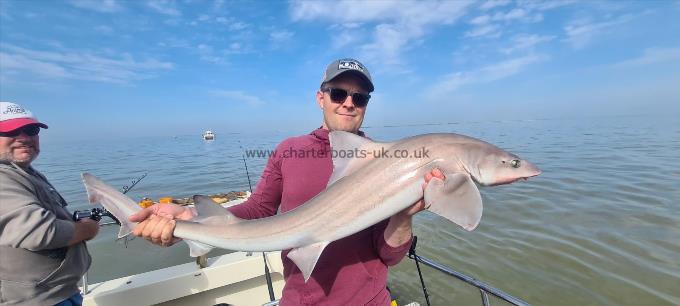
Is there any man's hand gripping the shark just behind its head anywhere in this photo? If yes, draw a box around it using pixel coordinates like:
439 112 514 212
385 168 445 247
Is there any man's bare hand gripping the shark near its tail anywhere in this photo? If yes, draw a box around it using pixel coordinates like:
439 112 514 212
128 204 194 246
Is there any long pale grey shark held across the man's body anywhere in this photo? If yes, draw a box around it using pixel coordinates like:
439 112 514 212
82 131 541 281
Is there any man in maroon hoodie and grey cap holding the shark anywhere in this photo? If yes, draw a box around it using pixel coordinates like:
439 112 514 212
130 59 444 305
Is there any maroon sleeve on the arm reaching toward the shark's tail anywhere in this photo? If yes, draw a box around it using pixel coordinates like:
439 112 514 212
228 145 283 219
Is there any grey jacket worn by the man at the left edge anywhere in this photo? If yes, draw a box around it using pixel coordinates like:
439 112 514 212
0 162 92 306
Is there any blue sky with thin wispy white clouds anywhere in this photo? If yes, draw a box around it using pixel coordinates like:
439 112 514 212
0 0 680 140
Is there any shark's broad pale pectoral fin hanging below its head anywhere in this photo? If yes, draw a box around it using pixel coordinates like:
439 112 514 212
425 173 482 231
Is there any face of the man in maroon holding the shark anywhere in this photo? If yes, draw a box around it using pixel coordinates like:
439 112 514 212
316 73 368 133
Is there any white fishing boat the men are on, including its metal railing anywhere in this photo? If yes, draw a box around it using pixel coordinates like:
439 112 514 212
81 193 530 306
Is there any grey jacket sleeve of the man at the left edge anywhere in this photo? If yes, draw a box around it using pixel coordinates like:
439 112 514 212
0 171 75 251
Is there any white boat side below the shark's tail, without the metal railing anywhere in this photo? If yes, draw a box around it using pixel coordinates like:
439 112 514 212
81 252 284 306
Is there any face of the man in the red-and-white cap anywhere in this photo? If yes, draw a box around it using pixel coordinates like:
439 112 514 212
0 128 40 167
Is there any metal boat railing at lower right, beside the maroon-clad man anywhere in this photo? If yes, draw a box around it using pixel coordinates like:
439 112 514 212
408 236 531 306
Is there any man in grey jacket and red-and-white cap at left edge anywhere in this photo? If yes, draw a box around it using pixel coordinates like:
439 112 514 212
0 102 99 306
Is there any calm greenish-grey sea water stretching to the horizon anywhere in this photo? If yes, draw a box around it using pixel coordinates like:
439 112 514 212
35 117 680 305
